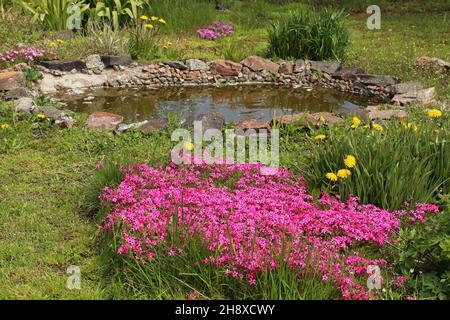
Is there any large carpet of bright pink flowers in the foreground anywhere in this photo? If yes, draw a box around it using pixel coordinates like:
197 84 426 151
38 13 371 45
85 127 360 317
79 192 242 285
100 163 440 299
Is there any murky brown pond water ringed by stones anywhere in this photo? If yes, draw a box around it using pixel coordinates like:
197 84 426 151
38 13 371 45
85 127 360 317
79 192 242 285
57 85 376 122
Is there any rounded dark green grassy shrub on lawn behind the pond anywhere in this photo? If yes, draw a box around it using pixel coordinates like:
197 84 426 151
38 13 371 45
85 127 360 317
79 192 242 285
268 8 349 60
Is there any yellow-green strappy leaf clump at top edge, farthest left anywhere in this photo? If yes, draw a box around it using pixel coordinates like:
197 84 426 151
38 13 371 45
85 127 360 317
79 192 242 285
20 0 89 31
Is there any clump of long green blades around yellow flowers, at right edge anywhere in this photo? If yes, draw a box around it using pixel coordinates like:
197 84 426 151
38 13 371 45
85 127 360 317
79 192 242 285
305 112 450 209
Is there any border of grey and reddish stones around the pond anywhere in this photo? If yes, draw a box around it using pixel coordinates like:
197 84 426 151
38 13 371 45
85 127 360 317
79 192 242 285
0 55 442 133
